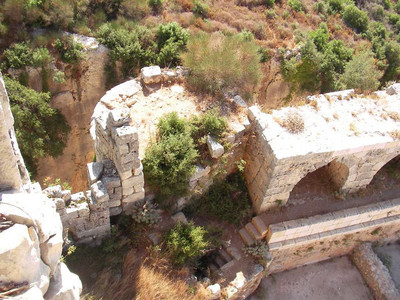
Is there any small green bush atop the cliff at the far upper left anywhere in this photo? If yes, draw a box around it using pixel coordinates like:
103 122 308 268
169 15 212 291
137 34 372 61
2 42 51 69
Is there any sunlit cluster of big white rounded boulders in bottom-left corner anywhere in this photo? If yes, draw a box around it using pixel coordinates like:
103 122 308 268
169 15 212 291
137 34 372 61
0 193 82 299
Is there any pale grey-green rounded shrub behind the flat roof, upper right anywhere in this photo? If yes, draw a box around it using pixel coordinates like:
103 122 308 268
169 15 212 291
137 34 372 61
340 52 382 92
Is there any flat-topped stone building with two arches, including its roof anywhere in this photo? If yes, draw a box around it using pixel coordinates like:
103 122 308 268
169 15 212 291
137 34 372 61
245 84 400 214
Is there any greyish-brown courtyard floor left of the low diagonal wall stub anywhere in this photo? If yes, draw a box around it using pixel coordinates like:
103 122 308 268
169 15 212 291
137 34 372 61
248 256 374 300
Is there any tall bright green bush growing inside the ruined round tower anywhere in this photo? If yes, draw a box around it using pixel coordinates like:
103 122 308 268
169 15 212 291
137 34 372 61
143 113 198 197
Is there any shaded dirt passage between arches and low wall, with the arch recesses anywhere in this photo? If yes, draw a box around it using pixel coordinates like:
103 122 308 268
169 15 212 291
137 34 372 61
261 162 400 225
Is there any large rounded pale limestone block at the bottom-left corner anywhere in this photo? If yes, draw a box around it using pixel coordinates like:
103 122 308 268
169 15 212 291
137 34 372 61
0 224 50 294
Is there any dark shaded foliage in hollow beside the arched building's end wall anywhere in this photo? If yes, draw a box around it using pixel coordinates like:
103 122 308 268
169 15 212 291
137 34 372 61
185 173 251 225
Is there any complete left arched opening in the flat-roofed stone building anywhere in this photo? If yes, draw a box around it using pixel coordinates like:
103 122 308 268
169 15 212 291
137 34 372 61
288 160 349 205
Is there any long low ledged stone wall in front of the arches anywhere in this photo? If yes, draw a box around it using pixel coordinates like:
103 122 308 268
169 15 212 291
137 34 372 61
266 199 400 272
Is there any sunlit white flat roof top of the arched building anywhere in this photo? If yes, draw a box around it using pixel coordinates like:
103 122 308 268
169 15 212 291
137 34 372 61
249 84 400 159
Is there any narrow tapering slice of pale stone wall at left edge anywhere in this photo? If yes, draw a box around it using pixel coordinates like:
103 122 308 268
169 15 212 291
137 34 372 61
0 73 30 191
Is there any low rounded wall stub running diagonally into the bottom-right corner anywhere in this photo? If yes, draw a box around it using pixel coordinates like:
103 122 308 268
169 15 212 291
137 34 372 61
351 243 400 300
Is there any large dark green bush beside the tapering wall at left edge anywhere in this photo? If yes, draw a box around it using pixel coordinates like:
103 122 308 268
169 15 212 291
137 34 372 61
4 77 70 173
